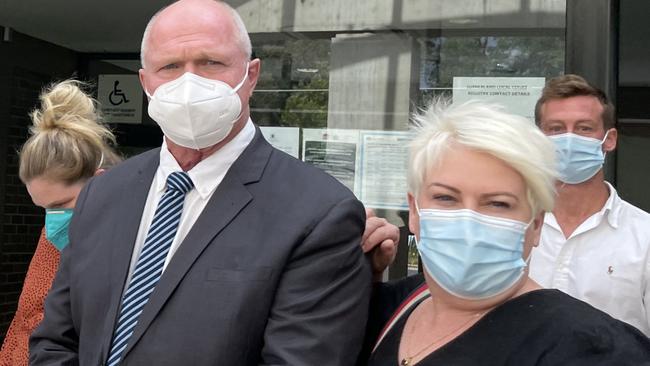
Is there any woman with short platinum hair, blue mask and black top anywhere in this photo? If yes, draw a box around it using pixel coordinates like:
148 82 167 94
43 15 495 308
368 100 650 366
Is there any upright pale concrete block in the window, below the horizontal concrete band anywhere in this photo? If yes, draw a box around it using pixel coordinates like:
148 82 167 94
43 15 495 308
327 34 413 130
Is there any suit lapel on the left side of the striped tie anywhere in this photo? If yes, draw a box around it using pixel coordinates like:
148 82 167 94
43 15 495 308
101 149 160 360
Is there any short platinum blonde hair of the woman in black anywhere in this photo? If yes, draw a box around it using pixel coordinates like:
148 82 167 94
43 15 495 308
408 99 557 214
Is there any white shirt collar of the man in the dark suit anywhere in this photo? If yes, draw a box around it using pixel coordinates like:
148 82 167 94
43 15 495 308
155 118 255 199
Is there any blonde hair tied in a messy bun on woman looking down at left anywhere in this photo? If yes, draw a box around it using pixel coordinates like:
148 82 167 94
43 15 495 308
19 80 121 184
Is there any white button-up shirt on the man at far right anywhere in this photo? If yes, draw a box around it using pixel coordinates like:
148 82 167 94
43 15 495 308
530 182 650 336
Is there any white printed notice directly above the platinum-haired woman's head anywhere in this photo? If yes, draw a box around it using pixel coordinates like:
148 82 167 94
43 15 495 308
453 77 546 119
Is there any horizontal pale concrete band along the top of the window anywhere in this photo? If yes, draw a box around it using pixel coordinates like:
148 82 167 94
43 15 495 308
237 0 566 33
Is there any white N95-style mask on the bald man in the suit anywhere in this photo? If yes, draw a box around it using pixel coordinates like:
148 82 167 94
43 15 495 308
147 63 248 149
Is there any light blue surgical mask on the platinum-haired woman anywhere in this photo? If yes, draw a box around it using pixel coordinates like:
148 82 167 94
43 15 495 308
418 209 529 300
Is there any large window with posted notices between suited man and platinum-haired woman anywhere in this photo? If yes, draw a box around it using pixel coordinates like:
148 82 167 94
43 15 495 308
243 0 566 277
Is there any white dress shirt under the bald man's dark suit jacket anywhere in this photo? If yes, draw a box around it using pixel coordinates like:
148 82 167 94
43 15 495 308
125 119 255 284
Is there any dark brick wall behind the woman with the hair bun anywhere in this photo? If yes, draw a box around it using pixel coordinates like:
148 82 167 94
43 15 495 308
0 32 78 341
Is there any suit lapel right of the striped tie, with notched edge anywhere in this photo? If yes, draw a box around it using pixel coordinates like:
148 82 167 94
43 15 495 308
122 127 273 359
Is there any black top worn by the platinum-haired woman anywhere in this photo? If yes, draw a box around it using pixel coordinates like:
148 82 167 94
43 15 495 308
367 276 650 366
